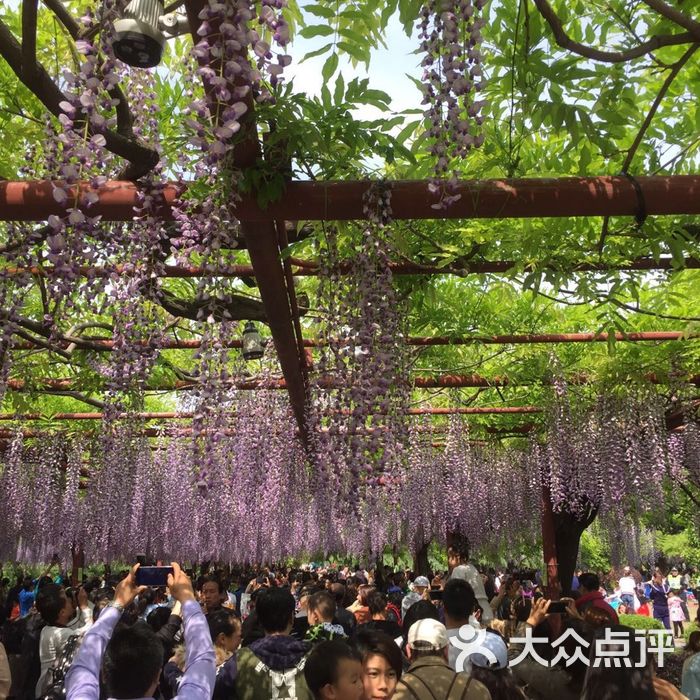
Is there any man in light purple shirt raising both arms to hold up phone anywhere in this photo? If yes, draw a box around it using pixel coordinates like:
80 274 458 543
66 562 216 700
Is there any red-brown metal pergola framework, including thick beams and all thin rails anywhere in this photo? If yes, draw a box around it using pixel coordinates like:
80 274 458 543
0 0 700 587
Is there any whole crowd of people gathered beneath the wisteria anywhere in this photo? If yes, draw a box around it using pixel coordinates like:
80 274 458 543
0 547 700 700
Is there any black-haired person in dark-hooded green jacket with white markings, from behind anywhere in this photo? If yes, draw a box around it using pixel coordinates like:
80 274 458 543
234 588 312 700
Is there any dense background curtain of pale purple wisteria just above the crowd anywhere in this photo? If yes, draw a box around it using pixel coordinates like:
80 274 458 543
0 382 698 562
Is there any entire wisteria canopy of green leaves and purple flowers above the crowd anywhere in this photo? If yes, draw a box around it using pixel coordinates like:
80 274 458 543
0 0 700 562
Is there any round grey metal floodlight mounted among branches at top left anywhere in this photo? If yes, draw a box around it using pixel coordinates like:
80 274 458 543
112 0 189 68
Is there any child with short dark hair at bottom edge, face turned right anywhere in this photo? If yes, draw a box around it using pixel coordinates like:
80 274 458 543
304 639 364 700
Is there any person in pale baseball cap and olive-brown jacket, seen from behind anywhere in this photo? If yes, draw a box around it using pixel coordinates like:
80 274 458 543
393 618 491 700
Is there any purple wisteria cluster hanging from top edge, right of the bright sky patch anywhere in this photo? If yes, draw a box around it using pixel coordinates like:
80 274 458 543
419 0 486 208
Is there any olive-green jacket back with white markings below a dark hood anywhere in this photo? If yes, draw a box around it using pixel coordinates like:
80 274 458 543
235 647 313 700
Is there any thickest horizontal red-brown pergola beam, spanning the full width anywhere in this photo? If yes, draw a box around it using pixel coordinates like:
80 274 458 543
0 175 700 222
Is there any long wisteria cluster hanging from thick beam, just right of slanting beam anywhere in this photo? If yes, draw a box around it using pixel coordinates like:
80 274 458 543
309 184 410 552
